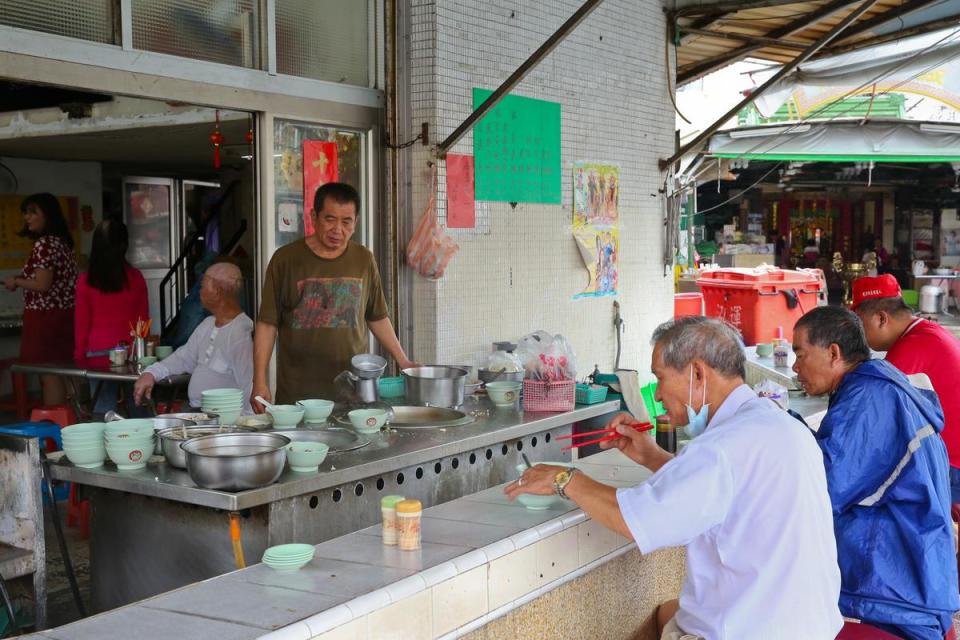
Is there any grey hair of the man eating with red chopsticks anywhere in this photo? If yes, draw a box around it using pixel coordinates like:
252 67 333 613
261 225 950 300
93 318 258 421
651 316 746 378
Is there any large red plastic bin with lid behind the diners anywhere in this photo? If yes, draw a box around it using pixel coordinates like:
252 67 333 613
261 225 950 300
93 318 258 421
697 269 821 345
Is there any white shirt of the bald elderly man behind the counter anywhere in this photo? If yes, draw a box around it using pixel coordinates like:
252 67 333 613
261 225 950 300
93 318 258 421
144 312 253 414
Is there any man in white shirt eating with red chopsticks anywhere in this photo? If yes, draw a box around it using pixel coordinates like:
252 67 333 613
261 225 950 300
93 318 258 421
505 317 843 640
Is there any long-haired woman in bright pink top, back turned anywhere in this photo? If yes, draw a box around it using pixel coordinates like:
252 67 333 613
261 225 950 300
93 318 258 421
73 217 150 413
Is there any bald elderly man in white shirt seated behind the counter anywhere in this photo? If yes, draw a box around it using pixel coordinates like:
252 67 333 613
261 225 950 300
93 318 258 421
133 262 253 414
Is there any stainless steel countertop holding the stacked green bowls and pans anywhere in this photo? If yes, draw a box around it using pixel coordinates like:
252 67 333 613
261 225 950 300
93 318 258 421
50 398 619 511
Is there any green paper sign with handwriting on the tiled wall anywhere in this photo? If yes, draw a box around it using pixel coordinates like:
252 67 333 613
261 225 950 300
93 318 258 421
473 88 560 204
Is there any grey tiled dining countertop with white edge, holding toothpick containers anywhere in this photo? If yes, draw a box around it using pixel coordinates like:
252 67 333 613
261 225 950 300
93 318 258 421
27 448 650 640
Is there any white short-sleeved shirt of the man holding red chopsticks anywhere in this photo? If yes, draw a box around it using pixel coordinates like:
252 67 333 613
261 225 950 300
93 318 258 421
617 385 843 640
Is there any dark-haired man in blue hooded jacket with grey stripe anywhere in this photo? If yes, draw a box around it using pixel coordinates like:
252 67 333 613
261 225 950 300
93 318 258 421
793 307 960 640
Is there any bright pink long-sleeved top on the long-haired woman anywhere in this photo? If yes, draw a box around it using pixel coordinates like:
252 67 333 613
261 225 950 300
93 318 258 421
73 266 150 362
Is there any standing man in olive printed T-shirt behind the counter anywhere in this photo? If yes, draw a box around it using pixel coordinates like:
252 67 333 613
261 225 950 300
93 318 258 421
250 182 413 413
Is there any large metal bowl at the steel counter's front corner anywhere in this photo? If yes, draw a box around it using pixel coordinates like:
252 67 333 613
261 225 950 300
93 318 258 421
180 432 290 491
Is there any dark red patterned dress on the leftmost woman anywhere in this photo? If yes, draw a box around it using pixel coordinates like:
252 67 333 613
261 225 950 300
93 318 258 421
19 236 77 363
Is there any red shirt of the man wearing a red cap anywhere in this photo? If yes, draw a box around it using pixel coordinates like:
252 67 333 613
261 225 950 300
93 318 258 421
887 318 960 467
